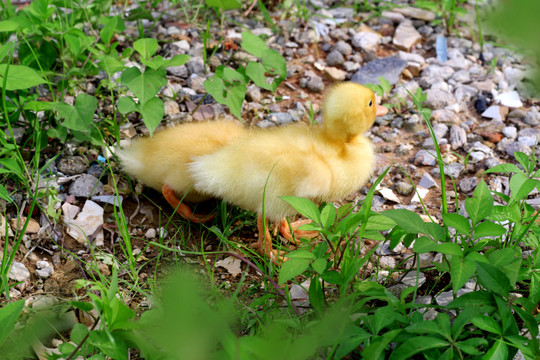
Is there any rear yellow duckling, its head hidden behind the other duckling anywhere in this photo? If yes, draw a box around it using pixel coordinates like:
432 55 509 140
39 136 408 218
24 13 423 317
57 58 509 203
117 120 247 223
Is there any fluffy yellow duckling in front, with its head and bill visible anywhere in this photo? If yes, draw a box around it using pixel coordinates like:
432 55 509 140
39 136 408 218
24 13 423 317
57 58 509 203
189 82 386 256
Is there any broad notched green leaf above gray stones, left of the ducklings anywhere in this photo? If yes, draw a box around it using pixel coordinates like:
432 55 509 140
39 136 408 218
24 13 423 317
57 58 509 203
56 93 97 132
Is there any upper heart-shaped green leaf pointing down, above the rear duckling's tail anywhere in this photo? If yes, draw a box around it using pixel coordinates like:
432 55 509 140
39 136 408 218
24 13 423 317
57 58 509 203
120 67 167 104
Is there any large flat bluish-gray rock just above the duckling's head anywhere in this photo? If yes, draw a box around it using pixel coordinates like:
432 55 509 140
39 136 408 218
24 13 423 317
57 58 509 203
351 57 407 84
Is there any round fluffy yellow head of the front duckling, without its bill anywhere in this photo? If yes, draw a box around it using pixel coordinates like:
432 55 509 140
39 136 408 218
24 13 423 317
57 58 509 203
323 82 377 142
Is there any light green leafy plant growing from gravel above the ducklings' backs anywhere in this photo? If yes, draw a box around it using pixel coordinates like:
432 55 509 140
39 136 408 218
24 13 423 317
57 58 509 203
204 31 287 119
